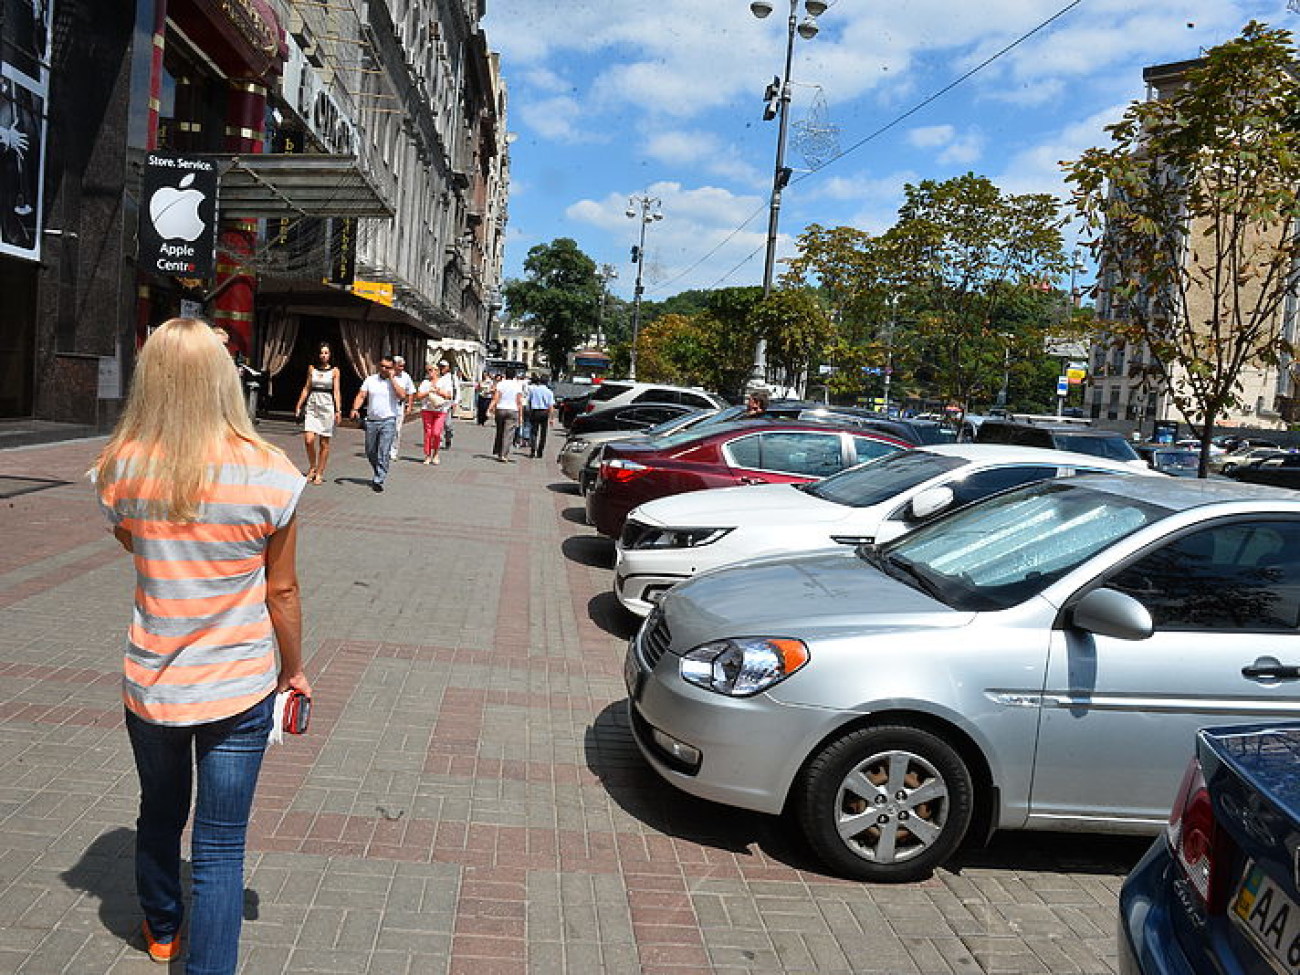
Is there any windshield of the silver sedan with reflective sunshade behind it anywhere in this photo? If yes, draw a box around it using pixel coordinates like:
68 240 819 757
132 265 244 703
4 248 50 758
863 481 1169 611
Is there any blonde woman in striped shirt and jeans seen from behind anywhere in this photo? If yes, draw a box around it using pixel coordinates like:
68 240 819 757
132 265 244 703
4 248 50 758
90 319 311 975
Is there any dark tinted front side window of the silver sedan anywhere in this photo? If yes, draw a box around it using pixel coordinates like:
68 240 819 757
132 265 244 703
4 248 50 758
1108 521 1300 631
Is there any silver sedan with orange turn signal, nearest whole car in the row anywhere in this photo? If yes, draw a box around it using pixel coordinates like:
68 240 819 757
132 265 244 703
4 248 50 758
624 477 1300 880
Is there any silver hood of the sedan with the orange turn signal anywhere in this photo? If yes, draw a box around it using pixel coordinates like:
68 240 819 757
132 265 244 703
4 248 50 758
663 551 975 647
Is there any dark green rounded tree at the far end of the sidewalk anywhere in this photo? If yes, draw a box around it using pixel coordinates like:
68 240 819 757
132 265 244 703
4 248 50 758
502 237 601 374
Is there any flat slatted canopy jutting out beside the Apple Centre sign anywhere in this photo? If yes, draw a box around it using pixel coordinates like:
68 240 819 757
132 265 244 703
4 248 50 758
204 153 394 220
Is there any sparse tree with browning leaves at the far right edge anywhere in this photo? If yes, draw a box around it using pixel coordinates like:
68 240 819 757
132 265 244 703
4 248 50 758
1066 21 1300 477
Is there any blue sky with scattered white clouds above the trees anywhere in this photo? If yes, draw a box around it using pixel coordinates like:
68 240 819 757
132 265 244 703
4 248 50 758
484 0 1284 299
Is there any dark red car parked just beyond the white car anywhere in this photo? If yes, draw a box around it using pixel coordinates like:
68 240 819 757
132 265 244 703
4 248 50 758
586 420 911 538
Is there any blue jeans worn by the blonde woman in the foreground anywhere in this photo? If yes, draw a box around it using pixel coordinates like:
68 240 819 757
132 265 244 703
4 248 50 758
126 694 276 975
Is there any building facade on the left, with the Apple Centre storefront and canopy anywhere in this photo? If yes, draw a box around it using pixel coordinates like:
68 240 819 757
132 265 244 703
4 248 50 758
0 0 510 429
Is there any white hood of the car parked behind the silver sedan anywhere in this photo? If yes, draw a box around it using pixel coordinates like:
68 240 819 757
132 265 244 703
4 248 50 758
633 484 853 528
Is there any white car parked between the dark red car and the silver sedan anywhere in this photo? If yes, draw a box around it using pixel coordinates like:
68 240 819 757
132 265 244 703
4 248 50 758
614 443 1165 616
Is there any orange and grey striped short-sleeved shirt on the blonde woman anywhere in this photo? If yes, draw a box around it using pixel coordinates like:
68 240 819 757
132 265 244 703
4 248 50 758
100 443 307 725
